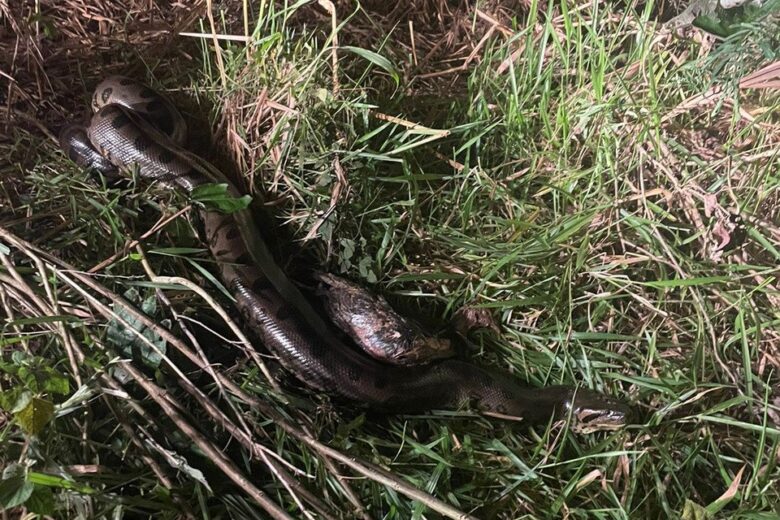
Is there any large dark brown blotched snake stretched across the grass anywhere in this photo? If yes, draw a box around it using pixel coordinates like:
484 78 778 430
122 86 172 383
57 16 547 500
60 76 629 431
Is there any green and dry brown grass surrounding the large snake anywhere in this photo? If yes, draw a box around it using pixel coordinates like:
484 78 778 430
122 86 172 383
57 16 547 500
0 1 780 519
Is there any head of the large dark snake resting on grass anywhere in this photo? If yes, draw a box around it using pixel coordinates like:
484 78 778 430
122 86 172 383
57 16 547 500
566 388 632 433
